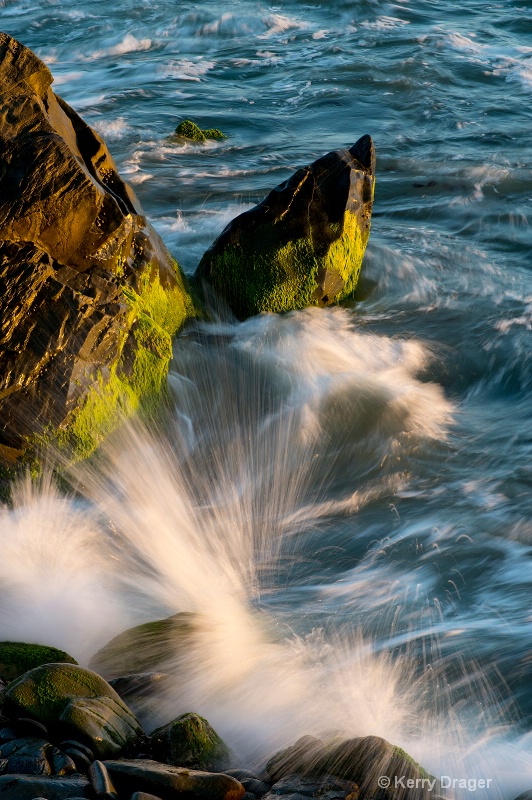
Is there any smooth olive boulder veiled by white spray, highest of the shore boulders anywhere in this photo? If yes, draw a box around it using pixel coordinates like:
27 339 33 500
89 612 195 680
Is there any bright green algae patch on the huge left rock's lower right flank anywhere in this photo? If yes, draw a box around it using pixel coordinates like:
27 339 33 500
58 264 196 460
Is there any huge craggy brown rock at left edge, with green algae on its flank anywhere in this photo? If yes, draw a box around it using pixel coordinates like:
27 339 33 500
0 33 193 464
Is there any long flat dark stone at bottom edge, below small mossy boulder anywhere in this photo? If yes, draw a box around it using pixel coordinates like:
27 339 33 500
104 759 245 800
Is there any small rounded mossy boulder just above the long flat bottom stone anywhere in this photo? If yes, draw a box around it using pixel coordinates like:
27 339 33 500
150 713 231 771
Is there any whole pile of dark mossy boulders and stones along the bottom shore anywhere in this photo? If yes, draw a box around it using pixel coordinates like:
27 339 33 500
0 636 436 800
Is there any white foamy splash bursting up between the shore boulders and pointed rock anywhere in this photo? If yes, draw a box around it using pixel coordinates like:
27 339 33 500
0 309 532 792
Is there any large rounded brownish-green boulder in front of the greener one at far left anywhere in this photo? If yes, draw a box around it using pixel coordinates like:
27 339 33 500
5 664 142 758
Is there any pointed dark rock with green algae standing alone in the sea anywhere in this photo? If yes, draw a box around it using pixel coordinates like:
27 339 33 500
194 135 375 319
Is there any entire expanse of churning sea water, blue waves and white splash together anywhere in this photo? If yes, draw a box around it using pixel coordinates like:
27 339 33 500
0 0 532 800
